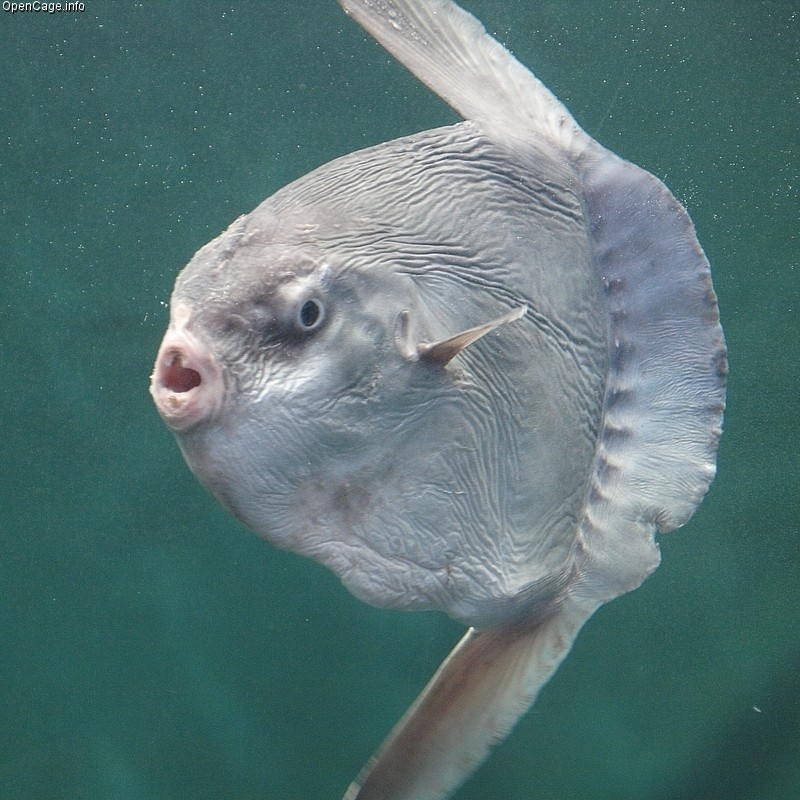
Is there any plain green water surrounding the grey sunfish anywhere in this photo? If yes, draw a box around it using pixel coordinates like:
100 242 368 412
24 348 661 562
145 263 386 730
0 0 800 800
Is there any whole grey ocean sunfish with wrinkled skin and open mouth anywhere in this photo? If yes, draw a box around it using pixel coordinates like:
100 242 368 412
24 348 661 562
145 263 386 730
151 0 726 800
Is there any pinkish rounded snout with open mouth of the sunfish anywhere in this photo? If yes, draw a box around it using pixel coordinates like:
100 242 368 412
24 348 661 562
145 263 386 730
150 330 223 431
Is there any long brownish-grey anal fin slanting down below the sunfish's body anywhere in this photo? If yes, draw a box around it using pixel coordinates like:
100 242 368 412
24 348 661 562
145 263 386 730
343 598 597 800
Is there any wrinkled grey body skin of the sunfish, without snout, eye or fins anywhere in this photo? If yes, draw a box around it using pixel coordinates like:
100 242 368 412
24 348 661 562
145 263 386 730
159 122 608 626
